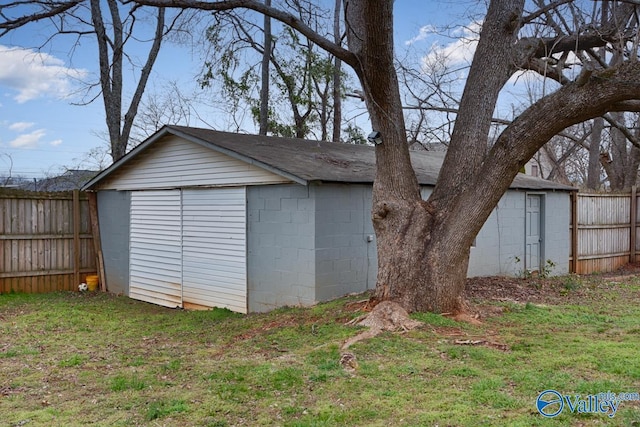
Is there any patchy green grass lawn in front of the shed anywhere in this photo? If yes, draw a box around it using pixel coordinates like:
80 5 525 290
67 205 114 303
0 276 640 427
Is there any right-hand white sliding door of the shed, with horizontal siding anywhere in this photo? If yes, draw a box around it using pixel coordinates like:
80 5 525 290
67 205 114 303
182 187 247 313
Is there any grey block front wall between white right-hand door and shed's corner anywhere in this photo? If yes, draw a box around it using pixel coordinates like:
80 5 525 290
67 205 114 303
247 184 317 311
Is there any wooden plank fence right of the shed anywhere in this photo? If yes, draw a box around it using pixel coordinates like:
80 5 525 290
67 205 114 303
571 187 640 274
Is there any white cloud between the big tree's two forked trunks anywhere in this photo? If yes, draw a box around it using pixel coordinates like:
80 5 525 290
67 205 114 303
422 23 482 67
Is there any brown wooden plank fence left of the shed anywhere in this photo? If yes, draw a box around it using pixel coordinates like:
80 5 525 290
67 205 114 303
0 190 97 293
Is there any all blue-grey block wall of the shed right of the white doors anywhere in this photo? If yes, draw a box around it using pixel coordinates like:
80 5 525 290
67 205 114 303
247 183 569 311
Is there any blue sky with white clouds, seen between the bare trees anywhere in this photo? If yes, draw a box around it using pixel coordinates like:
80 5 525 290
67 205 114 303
0 0 477 178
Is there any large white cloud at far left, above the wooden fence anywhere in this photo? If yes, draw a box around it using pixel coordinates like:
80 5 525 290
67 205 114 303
0 45 87 103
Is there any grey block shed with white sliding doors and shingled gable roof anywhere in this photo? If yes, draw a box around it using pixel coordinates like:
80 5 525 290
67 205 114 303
84 126 574 313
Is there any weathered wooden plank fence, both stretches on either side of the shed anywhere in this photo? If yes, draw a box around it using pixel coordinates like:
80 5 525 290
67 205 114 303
0 187 640 294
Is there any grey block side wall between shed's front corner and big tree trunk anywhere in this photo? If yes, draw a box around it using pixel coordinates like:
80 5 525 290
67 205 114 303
311 184 377 301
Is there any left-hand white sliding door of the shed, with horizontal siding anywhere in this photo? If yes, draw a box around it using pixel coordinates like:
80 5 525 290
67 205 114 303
129 190 182 307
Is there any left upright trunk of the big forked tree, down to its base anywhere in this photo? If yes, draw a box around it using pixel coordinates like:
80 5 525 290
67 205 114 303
344 0 431 310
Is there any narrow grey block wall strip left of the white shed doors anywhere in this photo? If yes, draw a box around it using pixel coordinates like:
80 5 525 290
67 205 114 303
98 190 131 295
